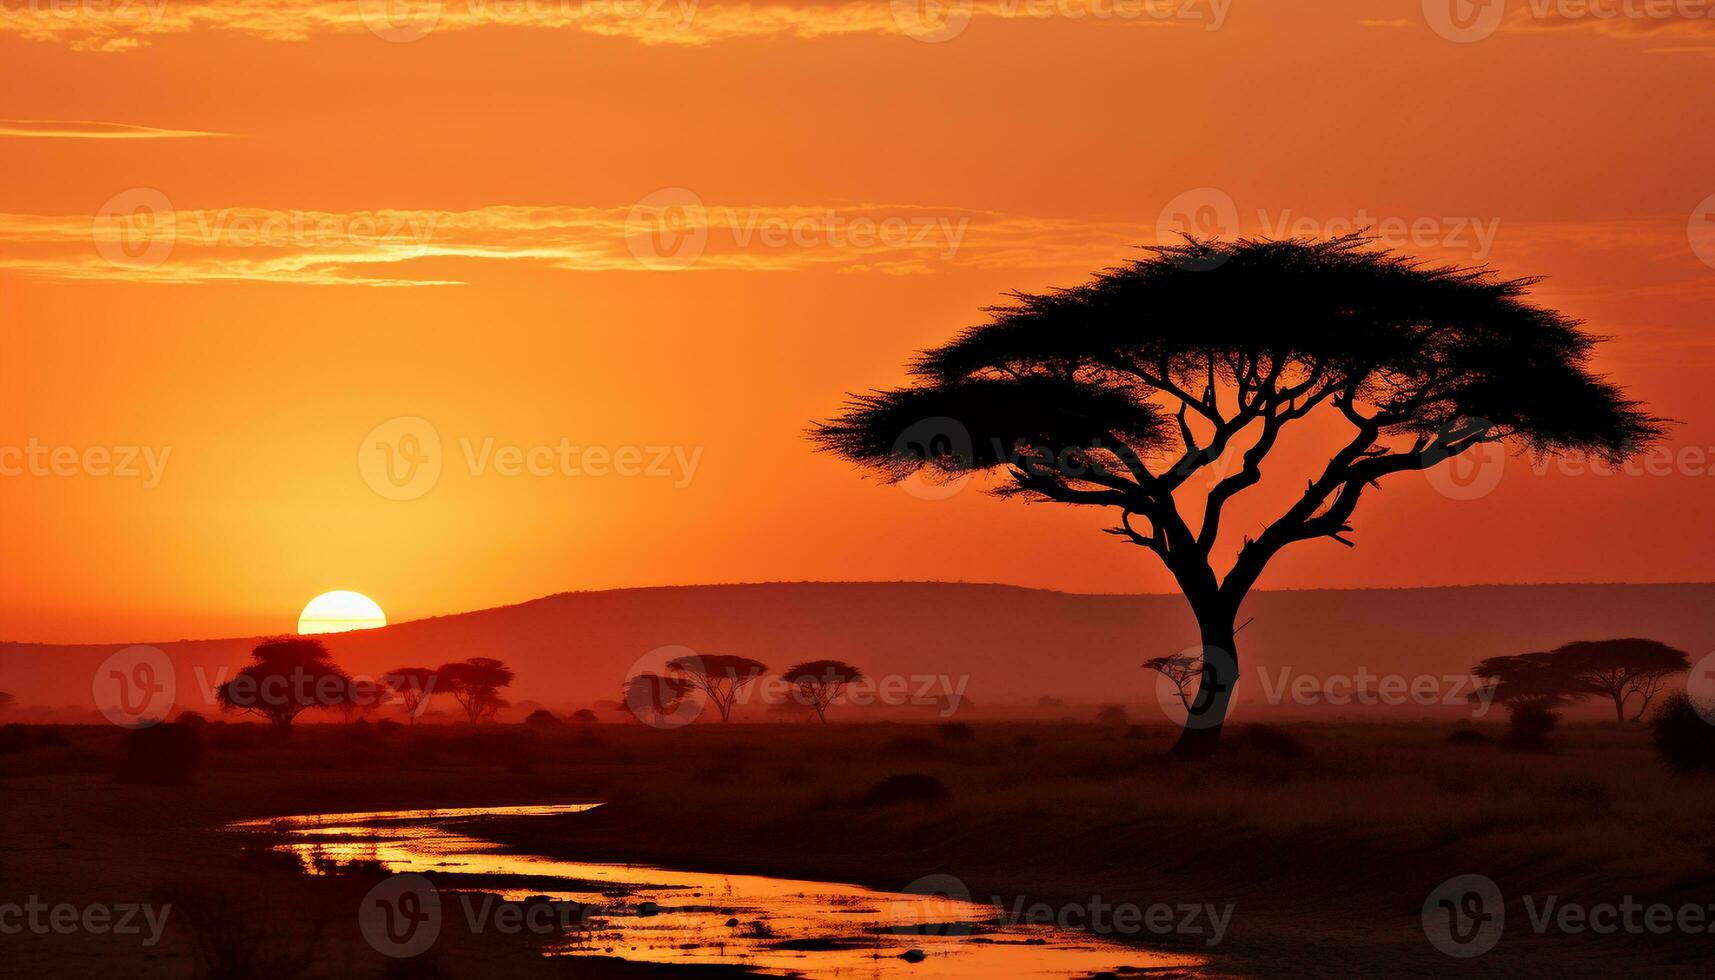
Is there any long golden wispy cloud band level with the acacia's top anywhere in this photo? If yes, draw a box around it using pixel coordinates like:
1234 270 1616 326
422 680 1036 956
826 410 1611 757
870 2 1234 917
0 201 1140 287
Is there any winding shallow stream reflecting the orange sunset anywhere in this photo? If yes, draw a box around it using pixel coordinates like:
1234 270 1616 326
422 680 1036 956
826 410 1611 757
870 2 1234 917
232 803 1202 978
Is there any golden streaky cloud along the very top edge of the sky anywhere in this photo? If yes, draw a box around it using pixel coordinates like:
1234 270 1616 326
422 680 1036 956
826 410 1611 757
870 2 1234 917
0 0 1231 51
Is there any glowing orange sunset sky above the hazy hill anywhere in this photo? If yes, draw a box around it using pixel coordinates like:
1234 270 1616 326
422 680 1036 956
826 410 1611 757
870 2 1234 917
0 0 1715 640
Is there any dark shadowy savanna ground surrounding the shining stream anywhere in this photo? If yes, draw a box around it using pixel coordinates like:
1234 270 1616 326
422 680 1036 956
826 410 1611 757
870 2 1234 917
0 724 1715 978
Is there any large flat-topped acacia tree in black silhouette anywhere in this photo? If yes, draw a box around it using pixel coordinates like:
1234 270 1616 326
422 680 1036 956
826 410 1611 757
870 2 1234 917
811 235 1664 755
